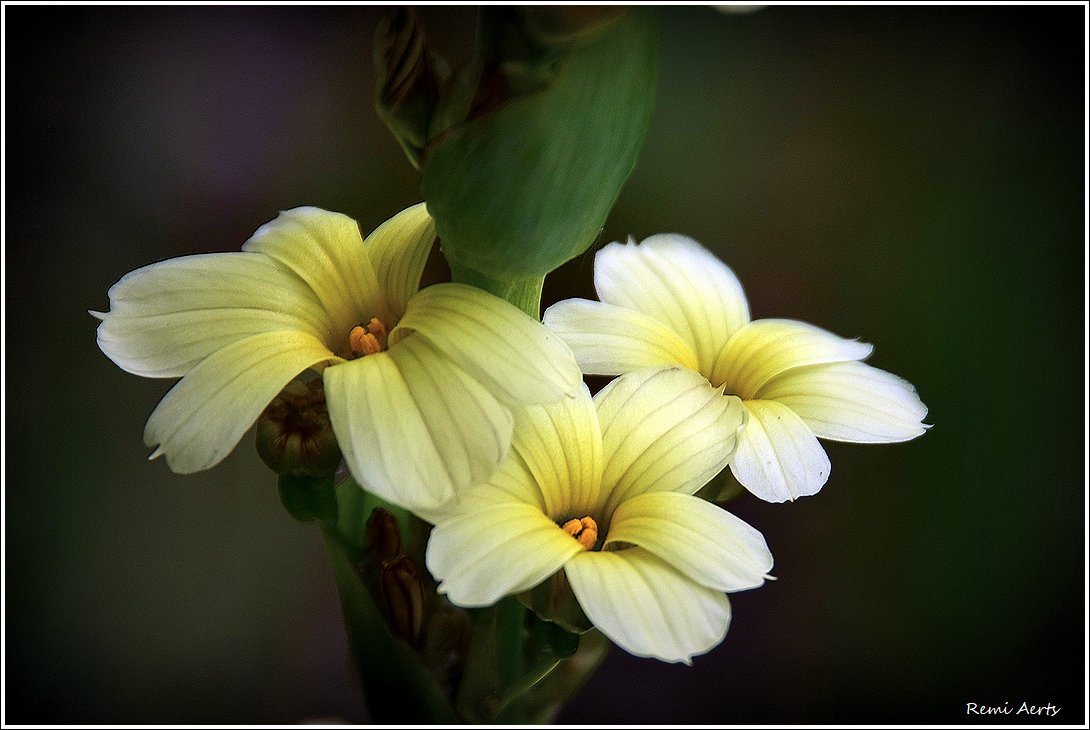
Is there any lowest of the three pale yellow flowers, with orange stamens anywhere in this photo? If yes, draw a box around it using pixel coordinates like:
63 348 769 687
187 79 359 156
427 368 772 662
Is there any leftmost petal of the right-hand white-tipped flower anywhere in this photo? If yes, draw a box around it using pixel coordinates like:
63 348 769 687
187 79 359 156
544 299 700 375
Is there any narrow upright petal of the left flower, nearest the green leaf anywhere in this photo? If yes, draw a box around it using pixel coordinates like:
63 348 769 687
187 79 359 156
363 203 435 320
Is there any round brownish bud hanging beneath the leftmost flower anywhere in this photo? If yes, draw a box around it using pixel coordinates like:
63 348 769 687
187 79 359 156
257 378 341 477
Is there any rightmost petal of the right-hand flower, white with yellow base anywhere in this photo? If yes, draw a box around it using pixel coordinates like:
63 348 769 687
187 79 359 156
758 363 928 443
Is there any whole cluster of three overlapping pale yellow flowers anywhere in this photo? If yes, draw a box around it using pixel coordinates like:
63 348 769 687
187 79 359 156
93 204 927 662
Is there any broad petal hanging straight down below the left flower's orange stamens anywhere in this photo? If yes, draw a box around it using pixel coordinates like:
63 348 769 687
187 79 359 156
323 338 512 513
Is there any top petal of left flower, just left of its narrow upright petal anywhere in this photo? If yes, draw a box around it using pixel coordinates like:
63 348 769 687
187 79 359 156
242 207 392 337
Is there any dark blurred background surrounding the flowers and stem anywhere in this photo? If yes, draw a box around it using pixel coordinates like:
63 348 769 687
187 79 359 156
4 5 1086 723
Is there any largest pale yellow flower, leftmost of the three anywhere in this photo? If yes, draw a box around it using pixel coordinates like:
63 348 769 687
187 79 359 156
92 204 581 511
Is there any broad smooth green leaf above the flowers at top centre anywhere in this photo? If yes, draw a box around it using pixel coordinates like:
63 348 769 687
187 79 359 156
422 8 657 289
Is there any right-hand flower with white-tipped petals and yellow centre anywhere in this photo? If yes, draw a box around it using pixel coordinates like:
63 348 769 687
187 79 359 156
545 234 928 502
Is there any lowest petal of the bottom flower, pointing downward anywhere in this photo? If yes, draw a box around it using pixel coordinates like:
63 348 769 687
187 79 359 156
565 548 730 664
